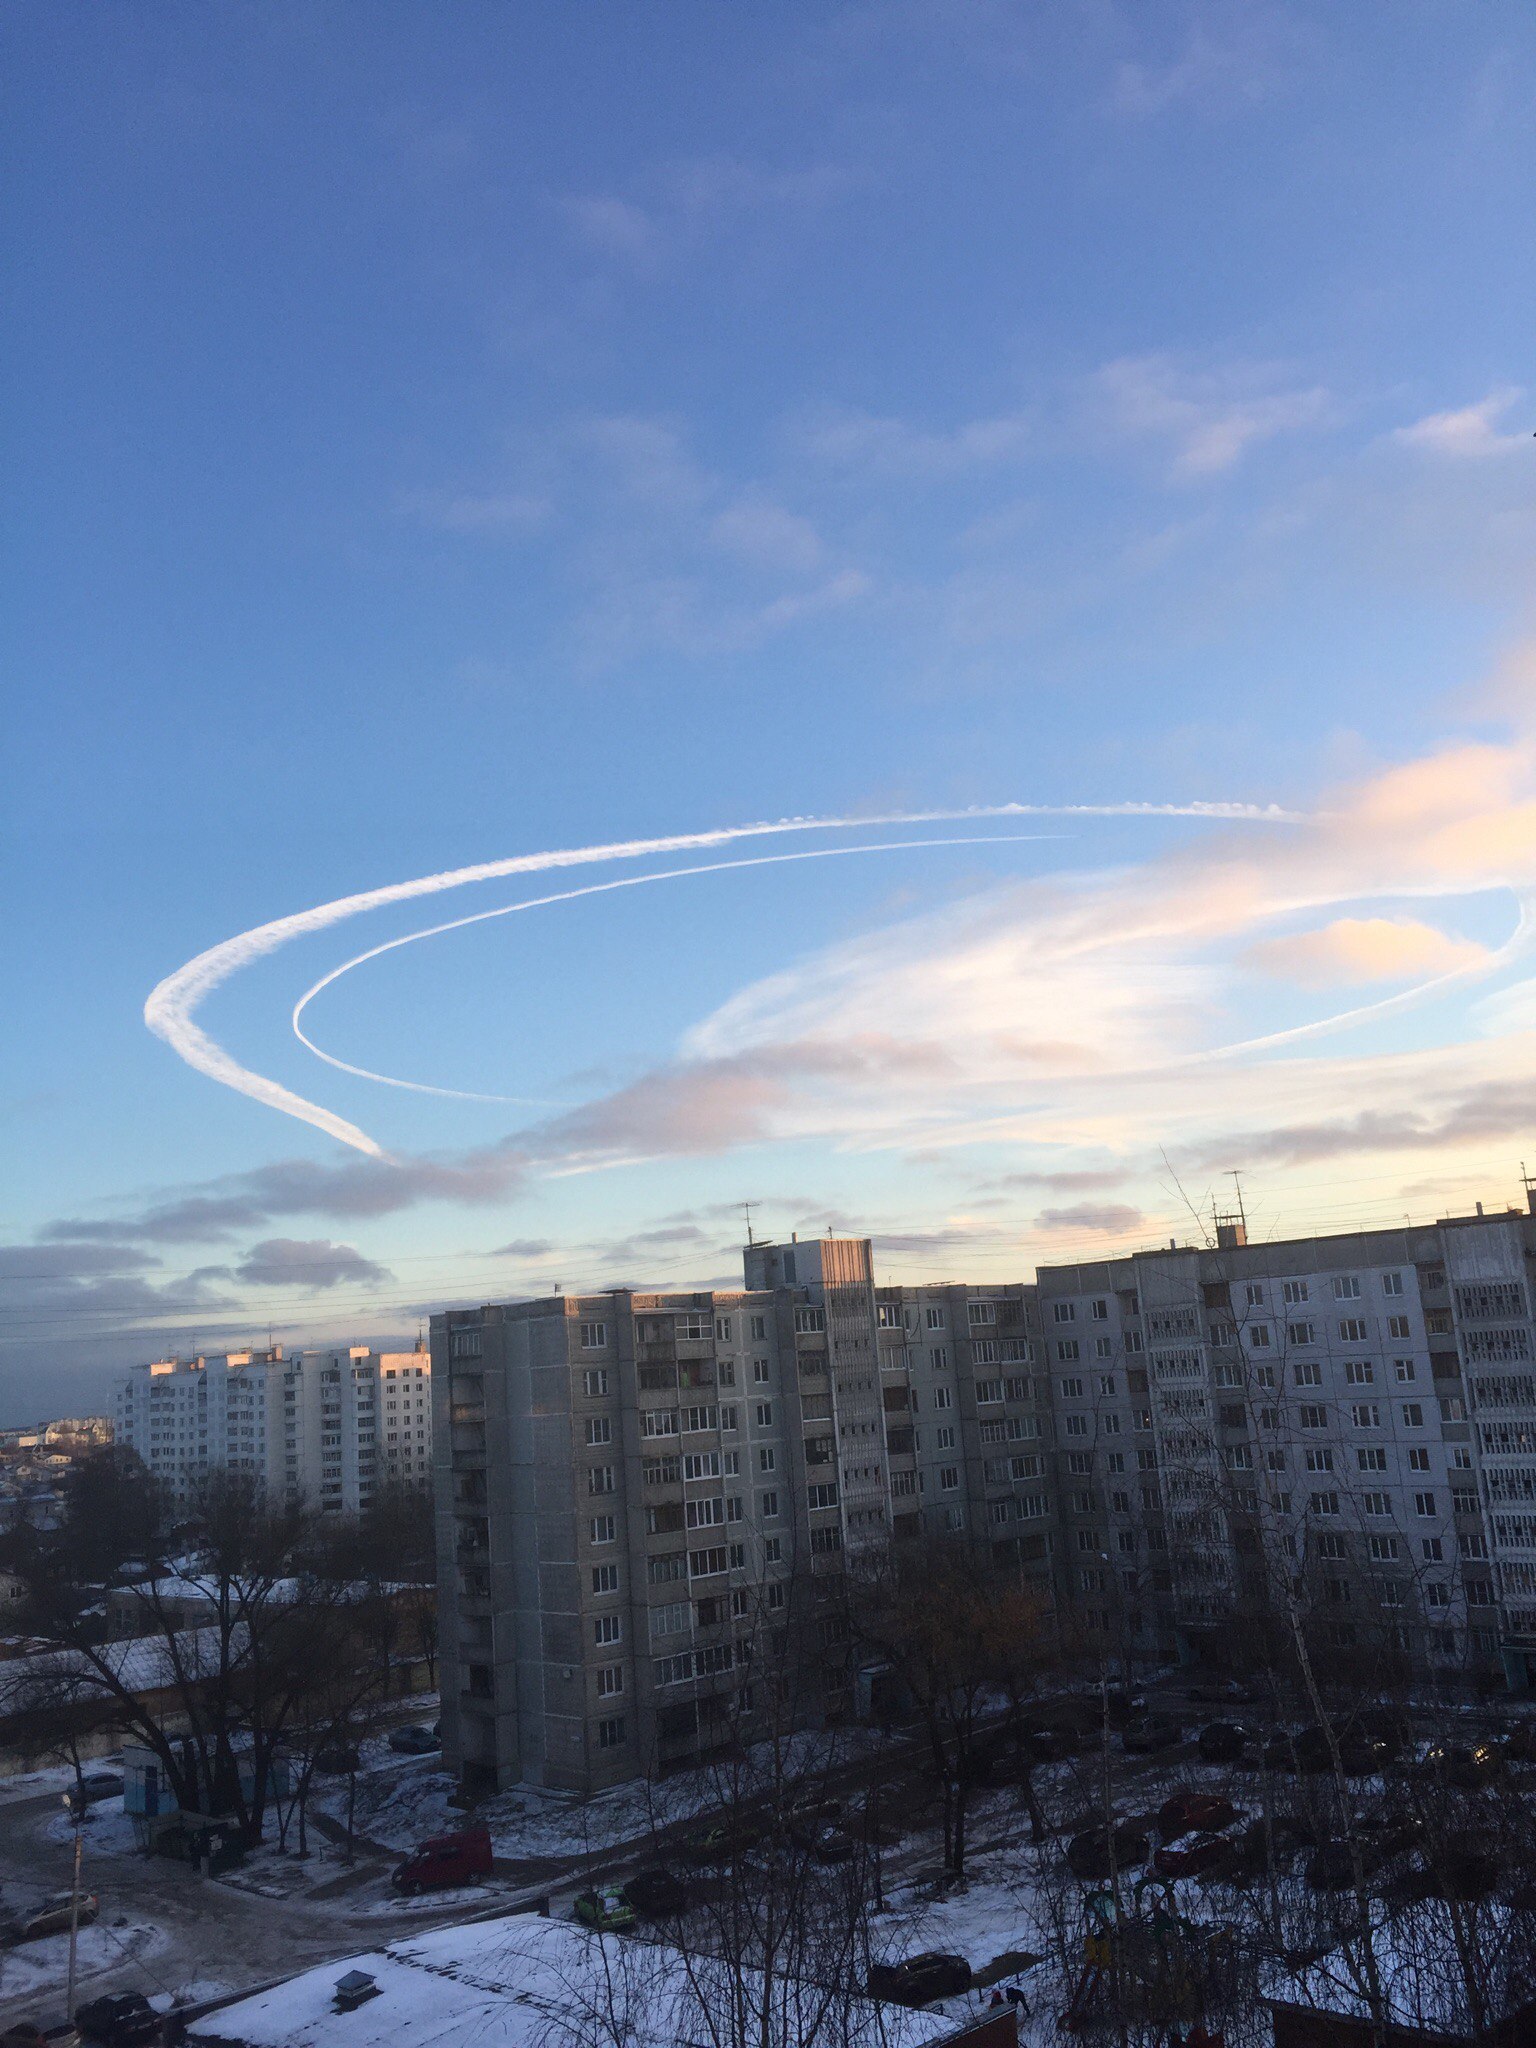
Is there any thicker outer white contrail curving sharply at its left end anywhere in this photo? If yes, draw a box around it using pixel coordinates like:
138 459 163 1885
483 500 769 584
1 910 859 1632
143 803 1303 1159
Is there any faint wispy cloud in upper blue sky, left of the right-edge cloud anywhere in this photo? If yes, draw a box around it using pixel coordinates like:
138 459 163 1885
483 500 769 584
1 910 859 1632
1094 354 1337 481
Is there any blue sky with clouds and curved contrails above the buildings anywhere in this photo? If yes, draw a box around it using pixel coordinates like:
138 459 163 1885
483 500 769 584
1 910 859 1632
0 0 1536 1423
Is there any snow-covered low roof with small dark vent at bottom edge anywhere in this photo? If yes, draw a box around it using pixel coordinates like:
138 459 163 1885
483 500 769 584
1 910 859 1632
188 1915 956 2048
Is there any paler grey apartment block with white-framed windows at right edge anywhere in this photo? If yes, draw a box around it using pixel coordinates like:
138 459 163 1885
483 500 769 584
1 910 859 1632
1038 1204 1536 1688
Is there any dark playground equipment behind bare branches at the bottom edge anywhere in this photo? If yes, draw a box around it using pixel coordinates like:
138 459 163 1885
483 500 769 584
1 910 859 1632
1061 1874 1231 2048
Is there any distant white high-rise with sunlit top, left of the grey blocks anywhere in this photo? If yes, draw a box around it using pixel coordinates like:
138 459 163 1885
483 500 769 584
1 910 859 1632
113 1343 432 1513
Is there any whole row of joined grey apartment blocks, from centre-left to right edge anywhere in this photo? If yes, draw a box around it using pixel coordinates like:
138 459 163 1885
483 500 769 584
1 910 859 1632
432 1198 1536 1790
